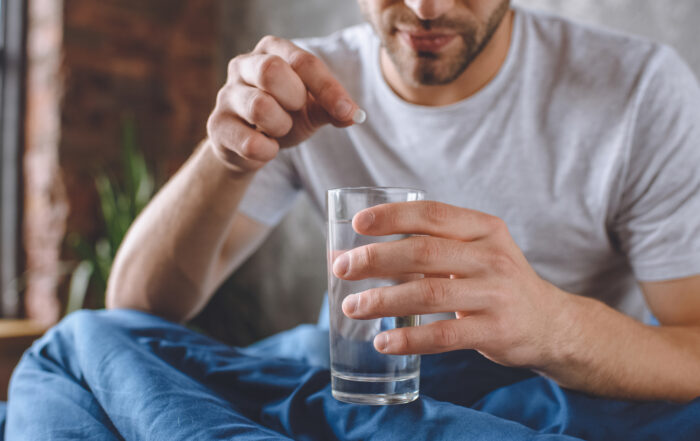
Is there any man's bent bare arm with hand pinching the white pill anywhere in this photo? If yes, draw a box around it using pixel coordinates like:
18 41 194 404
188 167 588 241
106 37 362 321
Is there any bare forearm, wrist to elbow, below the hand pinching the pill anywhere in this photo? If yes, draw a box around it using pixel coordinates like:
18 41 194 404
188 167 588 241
107 142 253 320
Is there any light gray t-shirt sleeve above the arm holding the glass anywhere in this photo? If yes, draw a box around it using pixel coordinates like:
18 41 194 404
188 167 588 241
614 47 700 281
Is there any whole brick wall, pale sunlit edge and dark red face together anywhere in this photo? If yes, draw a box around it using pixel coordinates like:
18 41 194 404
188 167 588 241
25 0 220 323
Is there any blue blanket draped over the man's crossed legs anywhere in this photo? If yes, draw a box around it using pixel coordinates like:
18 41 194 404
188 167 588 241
0 310 700 440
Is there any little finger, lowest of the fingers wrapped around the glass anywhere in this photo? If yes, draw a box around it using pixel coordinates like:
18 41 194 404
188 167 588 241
374 315 489 355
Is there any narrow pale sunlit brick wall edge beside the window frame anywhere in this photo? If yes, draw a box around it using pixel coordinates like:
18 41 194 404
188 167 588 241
24 0 68 323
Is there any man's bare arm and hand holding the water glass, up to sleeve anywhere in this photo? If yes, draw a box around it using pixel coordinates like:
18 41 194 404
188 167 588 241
333 202 700 401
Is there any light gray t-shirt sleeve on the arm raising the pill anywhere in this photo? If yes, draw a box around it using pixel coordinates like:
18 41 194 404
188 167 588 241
238 147 301 227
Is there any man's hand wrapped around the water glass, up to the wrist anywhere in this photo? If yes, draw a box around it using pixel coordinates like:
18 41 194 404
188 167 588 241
333 201 571 369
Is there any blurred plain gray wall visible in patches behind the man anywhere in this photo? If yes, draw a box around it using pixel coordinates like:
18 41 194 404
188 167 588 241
222 0 700 334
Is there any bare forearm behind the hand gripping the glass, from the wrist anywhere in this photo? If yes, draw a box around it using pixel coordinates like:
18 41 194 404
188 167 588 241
542 296 700 401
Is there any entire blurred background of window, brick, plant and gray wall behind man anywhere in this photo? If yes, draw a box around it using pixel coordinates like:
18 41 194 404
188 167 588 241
0 0 700 398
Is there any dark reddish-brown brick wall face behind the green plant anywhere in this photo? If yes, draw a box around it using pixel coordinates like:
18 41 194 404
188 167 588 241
60 0 218 237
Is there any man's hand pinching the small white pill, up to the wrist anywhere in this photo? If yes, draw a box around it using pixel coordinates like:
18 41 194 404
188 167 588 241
207 36 361 172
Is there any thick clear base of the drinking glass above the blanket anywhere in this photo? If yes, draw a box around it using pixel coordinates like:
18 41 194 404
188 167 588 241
331 372 420 405
